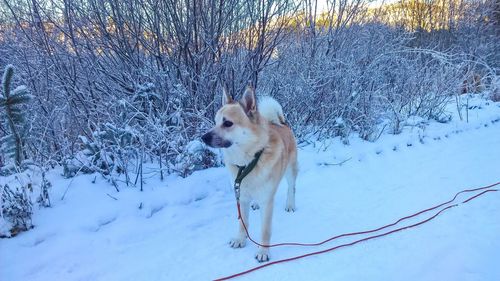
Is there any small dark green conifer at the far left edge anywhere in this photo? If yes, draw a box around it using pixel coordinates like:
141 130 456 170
0 64 32 167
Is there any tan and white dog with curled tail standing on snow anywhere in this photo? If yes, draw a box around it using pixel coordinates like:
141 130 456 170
202 87 298 262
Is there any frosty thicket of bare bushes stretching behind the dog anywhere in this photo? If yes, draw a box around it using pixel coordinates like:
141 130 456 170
0 0 494 179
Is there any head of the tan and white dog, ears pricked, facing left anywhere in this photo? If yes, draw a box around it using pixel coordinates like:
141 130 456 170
201 87 259 148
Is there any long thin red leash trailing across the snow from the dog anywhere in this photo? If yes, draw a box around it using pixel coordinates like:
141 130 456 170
216 182 500 281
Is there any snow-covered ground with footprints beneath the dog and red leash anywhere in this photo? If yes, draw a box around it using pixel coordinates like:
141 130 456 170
0 95 500 281
